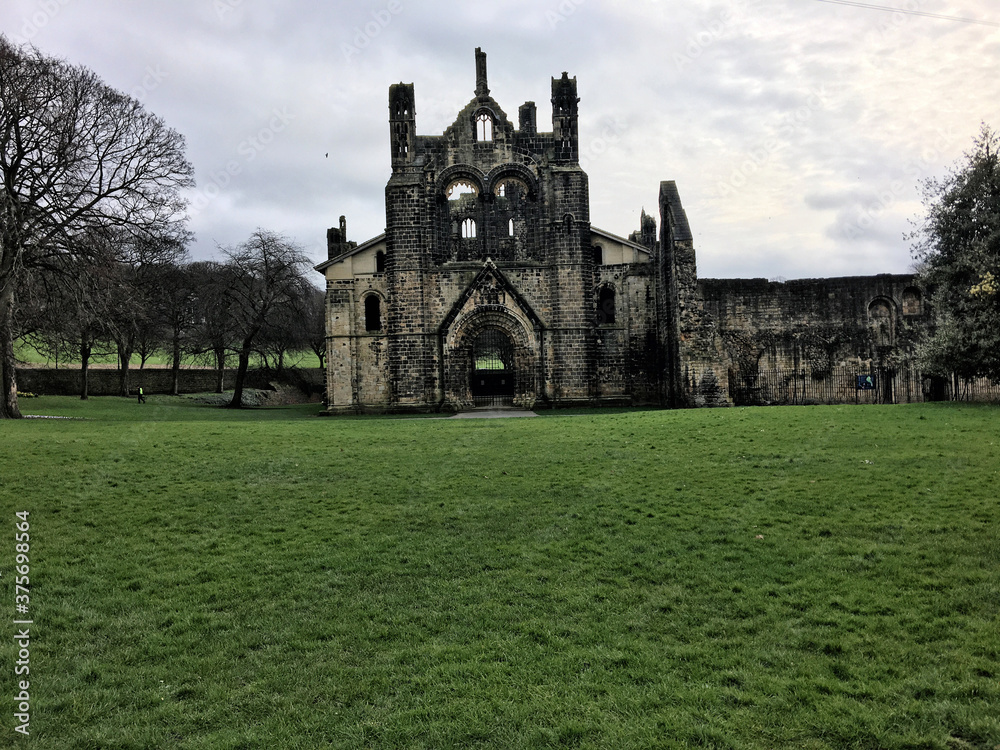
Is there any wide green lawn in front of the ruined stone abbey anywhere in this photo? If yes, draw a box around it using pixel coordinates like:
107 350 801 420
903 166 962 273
0 397 1000 750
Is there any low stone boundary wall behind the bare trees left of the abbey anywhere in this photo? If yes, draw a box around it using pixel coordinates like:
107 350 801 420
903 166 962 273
17 367 324 396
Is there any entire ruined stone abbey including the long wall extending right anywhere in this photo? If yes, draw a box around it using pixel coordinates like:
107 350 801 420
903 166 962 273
317 49 927 414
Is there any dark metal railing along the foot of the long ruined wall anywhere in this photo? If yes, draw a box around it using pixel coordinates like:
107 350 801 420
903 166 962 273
729 365 1000 406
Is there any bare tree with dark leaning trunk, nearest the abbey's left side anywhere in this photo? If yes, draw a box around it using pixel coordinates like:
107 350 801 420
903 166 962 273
224 229 309 409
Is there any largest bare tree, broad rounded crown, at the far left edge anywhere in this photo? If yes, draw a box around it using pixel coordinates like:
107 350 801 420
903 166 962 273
0 35 194 418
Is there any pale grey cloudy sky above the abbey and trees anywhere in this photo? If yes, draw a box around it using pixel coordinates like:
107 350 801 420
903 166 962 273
0 0 1000 279
